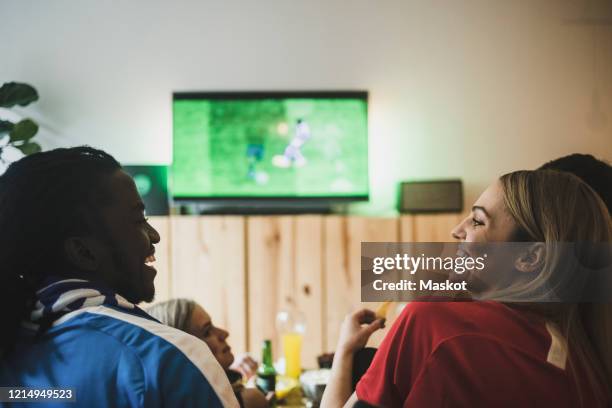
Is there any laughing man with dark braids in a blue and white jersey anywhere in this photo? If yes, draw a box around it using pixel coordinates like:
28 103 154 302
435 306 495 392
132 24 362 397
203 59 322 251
0 146 238 407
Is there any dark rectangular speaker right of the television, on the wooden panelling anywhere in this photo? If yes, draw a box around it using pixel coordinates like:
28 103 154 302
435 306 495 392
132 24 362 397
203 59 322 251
398 179 463 213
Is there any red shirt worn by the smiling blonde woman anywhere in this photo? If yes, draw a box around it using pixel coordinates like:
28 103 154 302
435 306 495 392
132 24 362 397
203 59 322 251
356 301 605 407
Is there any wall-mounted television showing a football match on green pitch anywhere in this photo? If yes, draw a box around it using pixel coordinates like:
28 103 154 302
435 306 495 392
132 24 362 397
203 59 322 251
171 92 368 200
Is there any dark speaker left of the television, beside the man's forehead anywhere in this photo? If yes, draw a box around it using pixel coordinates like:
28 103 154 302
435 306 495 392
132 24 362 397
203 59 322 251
123 166 169 215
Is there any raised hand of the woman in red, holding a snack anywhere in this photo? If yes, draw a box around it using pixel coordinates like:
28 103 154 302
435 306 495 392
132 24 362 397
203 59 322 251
336 309 385 354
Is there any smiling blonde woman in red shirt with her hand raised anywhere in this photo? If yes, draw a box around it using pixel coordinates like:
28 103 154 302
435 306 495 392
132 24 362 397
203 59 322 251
322 170 612 407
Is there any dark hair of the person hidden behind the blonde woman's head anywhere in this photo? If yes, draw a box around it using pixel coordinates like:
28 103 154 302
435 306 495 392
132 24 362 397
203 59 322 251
539 153 612 214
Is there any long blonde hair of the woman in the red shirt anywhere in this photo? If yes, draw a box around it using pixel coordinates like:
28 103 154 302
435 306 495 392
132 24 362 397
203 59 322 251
500 170 612 404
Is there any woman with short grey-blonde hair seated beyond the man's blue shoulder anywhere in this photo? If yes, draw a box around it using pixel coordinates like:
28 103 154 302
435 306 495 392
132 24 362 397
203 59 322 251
147 299 268 408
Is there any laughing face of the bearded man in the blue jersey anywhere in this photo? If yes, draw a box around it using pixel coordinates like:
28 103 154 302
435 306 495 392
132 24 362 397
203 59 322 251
92 170 160 303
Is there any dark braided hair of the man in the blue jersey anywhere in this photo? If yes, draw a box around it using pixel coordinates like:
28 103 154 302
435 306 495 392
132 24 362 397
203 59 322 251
0 146 121 355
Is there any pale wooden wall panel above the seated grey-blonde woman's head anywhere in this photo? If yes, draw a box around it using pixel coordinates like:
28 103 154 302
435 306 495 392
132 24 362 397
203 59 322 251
171 216 247 353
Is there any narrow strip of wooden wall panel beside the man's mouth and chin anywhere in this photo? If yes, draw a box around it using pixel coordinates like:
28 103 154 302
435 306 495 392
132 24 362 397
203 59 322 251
144 216 172 307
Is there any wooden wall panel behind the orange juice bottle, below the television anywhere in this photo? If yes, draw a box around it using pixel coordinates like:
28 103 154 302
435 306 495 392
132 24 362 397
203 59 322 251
247 216 324 368
